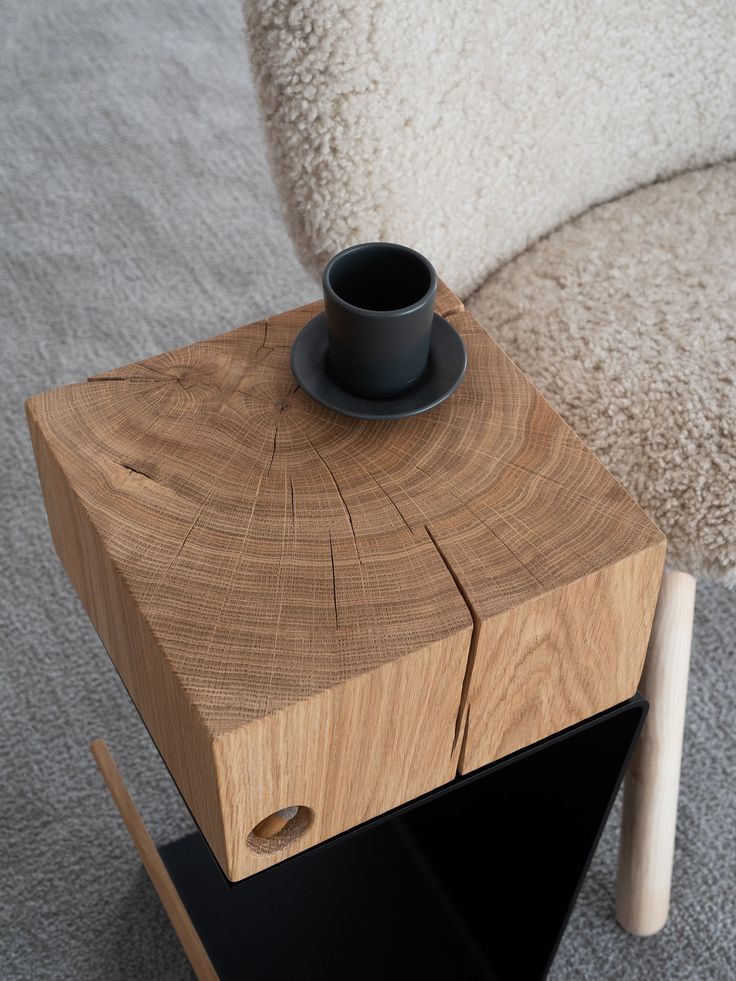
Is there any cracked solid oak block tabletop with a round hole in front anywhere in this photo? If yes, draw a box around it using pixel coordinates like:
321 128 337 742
28 285 664 878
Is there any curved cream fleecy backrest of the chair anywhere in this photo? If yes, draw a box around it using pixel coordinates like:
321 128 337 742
245 0 736 295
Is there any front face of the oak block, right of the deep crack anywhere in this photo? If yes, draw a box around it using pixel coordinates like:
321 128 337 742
459 549 663 773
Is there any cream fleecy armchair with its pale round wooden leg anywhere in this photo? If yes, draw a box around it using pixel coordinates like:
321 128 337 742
245 0 736 934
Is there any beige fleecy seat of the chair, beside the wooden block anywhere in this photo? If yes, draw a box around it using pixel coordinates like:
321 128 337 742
467 163 736 585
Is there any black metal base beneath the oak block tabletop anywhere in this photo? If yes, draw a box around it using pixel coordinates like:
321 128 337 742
160 696 647 981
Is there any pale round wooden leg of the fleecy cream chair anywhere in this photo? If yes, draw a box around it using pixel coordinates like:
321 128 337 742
616 572 695 937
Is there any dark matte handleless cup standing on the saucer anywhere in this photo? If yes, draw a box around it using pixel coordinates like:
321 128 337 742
322 242 437 399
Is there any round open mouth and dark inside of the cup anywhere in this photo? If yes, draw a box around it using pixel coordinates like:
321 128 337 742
326 243 432 311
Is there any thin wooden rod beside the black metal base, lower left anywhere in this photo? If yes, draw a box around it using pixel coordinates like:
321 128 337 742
90 739 218 981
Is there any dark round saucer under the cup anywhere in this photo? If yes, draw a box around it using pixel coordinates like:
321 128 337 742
291 313 468 419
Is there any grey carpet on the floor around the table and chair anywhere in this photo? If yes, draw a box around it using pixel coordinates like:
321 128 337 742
0 0 736 981
